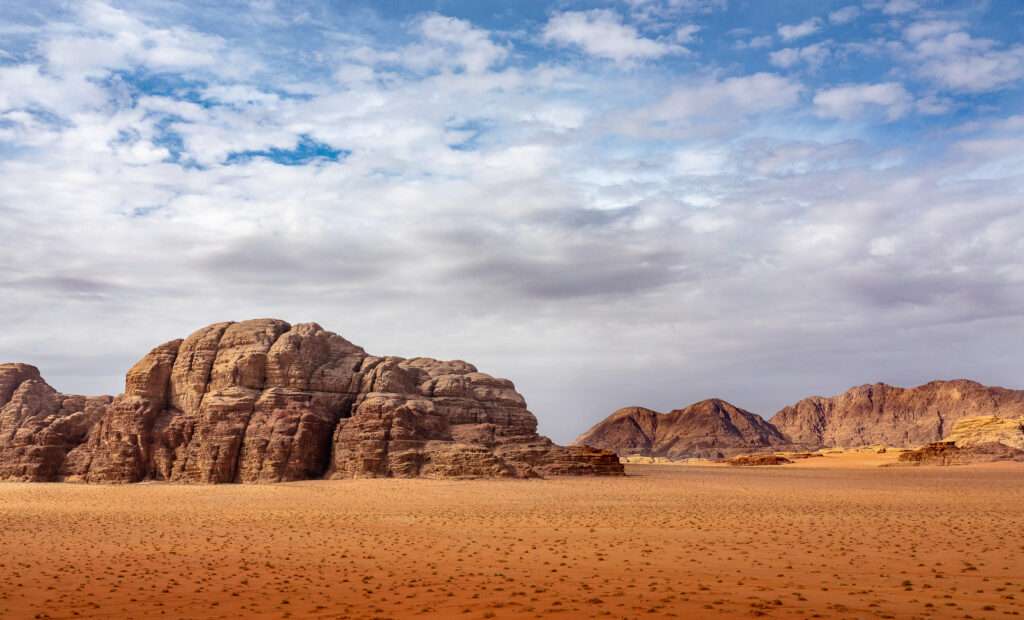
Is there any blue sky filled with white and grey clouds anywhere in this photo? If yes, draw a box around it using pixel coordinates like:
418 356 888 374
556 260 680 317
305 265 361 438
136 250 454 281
0 0 1024 442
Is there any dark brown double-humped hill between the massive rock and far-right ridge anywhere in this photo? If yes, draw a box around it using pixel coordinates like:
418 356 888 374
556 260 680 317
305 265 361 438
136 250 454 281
575 399 788 459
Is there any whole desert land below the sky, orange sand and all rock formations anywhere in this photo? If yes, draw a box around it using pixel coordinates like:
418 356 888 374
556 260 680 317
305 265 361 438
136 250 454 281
6 319 1024 618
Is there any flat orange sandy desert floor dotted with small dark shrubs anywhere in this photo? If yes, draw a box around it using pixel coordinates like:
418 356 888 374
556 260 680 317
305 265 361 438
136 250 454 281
0 455 1024 618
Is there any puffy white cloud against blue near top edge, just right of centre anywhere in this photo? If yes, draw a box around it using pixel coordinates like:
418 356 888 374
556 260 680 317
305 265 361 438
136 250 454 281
543 9 686 64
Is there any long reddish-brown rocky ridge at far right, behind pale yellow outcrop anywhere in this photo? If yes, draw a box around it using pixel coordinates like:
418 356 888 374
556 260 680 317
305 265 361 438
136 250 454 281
771 379 1024 448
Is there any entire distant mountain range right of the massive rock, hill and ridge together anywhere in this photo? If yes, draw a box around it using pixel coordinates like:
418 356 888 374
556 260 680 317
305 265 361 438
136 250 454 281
577 379 1024 460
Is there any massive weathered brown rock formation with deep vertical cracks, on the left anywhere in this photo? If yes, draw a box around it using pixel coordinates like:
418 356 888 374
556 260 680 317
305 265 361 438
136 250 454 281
0 319 623 483
